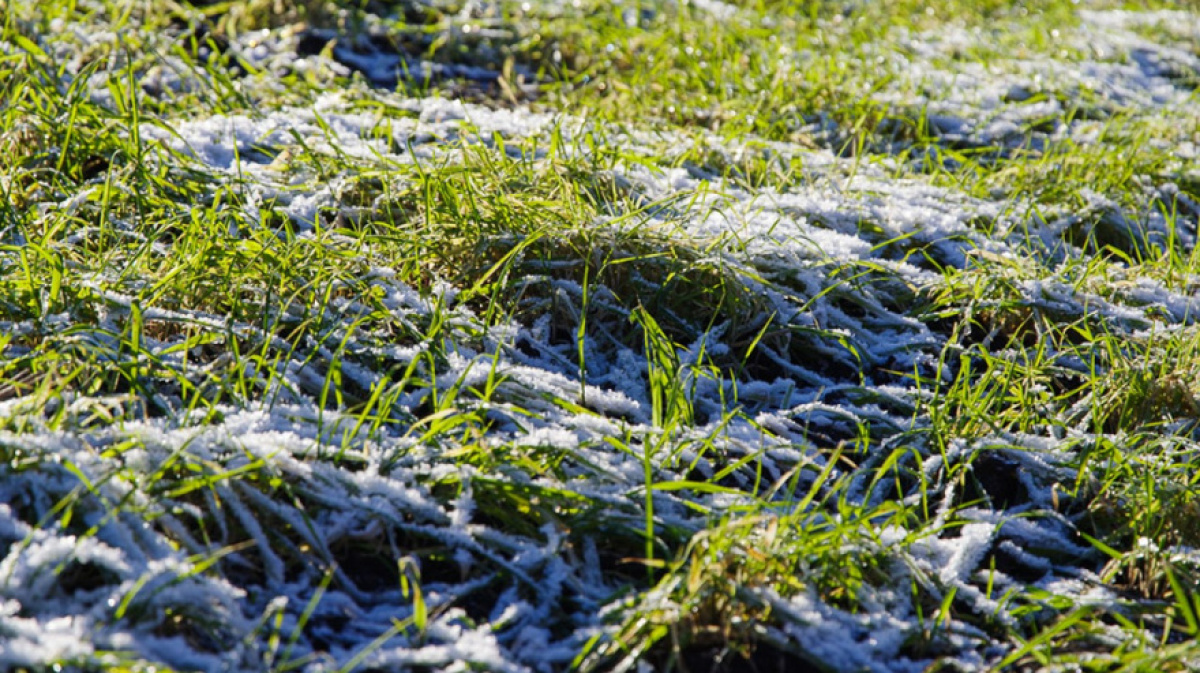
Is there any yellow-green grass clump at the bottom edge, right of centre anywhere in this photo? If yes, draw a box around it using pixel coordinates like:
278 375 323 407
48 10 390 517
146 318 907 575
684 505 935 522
580 472 904 669
